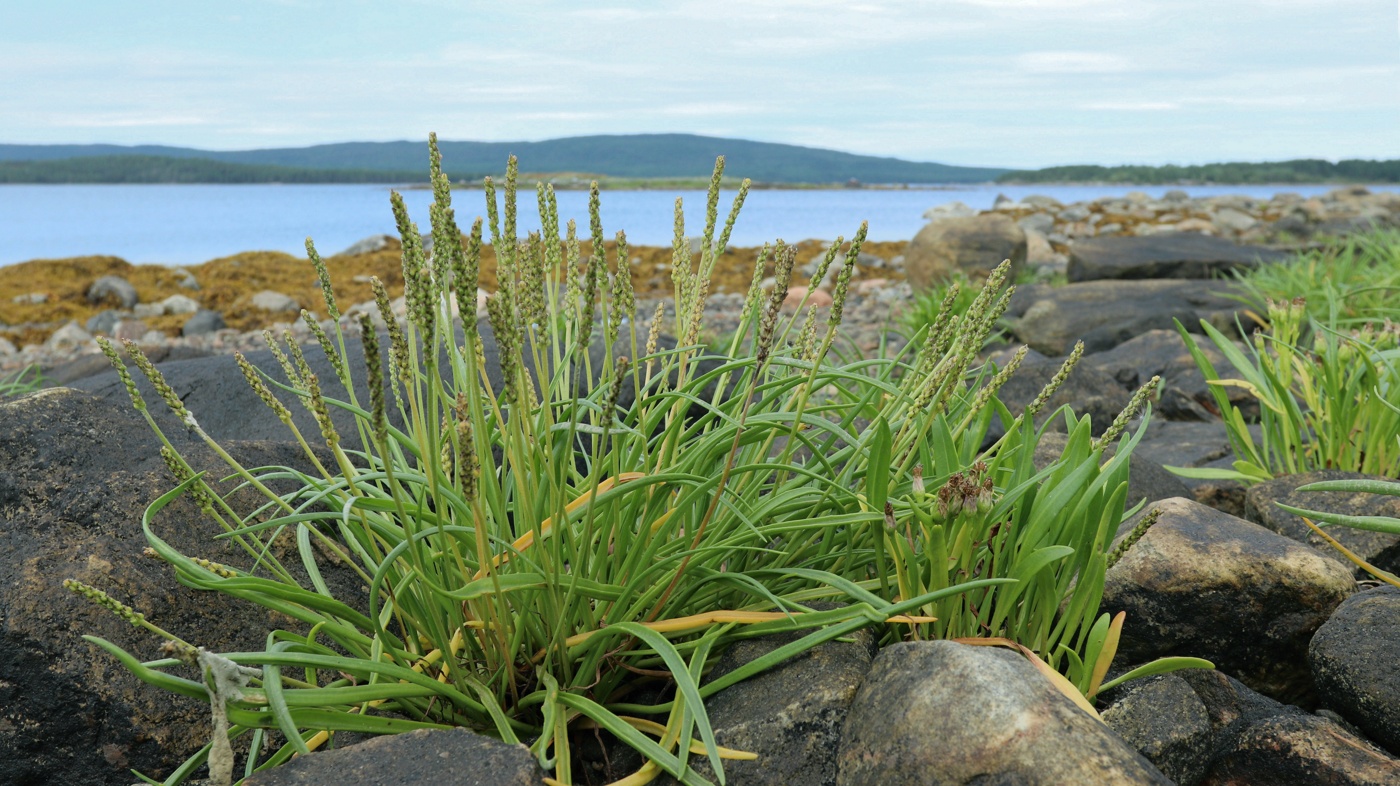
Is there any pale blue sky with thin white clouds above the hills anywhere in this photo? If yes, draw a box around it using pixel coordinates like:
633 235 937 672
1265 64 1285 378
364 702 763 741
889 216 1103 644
0 0 1400 167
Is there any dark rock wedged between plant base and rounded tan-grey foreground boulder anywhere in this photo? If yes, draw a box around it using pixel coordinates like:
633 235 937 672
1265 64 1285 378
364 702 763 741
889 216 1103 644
657 613 875 786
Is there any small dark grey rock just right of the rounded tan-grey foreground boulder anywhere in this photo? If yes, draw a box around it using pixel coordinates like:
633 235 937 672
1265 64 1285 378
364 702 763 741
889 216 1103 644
1099 674 1214 786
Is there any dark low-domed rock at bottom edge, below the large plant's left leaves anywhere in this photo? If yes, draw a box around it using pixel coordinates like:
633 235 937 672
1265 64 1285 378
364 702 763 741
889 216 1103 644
244 729 545 786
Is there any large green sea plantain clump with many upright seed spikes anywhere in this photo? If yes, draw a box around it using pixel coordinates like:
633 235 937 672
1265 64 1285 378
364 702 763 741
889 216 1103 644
69 143 1179 785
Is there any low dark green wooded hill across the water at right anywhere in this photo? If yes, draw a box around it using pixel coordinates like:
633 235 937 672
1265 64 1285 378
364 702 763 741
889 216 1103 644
997 158 1400 185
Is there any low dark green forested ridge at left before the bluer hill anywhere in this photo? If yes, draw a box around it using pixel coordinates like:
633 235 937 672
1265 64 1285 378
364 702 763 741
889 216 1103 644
0 156 423 184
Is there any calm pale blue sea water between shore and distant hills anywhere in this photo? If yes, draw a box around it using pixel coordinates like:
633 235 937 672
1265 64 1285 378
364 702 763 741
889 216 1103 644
0 184 1396 265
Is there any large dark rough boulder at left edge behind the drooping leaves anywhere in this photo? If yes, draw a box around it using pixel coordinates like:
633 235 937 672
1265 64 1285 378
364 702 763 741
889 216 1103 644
0 388 360 786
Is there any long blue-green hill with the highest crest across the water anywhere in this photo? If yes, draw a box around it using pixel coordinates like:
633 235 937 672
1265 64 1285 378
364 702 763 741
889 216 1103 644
0 133 1009 184
